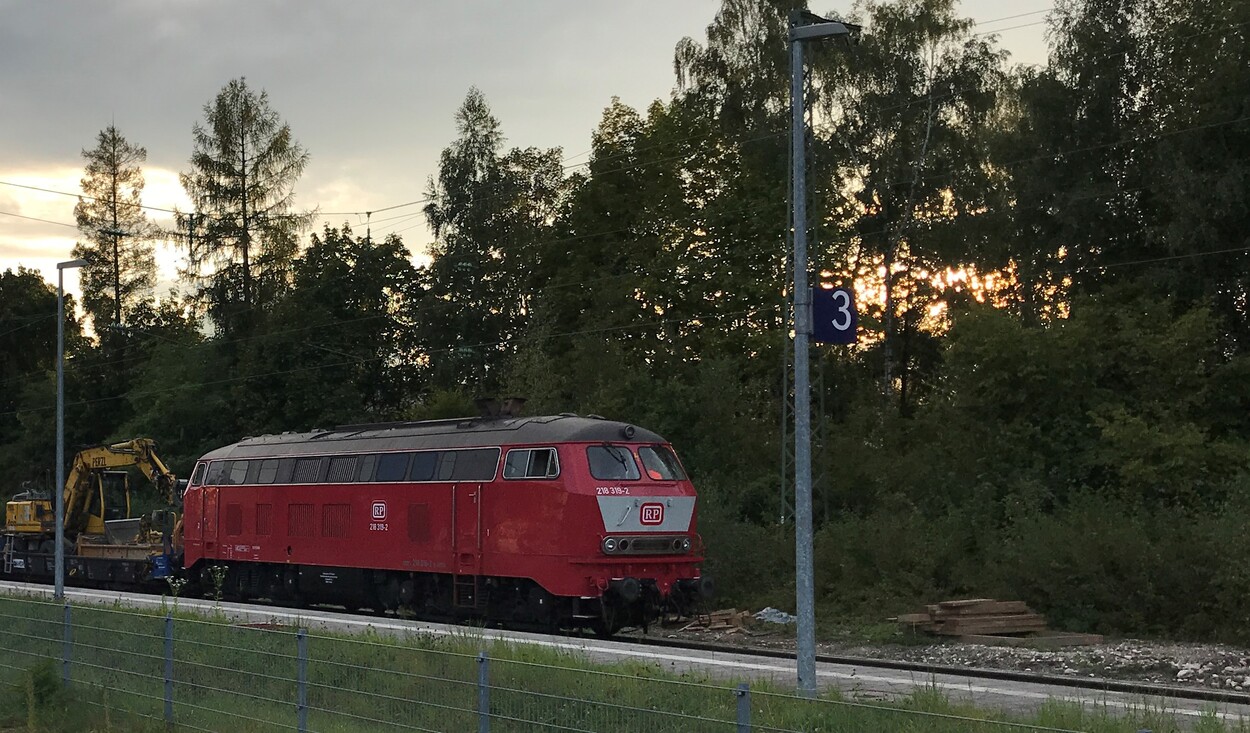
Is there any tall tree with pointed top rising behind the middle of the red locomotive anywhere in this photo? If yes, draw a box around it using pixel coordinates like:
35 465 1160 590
419 89 564 394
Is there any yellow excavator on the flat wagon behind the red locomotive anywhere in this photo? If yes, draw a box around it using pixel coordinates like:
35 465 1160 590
4 438 180 557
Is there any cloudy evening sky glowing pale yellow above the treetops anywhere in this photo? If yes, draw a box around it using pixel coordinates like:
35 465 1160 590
0 0 1051 291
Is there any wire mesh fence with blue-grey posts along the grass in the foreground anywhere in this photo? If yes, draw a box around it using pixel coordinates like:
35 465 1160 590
0 597 1095 733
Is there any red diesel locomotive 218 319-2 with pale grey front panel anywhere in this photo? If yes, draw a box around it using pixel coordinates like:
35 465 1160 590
184 414 711 633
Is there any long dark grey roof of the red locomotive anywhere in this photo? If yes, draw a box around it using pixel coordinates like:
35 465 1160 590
204 414 665 459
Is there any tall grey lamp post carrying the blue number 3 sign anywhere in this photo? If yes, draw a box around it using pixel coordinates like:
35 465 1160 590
790 10 860 697
